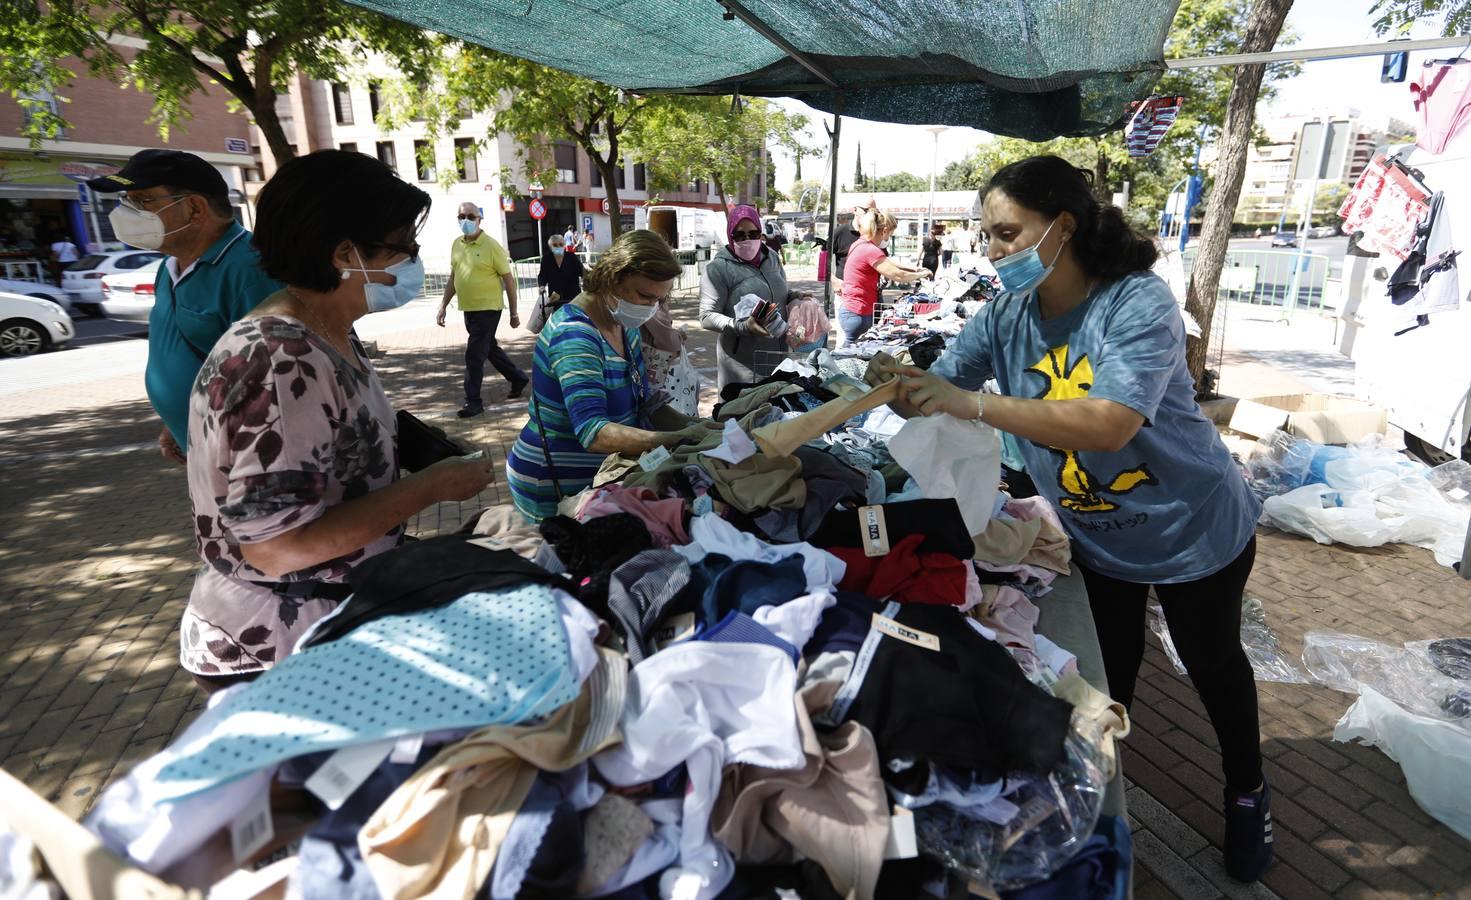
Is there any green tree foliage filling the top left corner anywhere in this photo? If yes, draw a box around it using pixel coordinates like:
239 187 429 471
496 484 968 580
0 0 447 160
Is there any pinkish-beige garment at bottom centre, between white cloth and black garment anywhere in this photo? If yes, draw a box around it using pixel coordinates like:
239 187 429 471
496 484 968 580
710 681 888 900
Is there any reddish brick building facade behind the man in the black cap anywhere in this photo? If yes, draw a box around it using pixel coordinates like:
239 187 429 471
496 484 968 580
0 41 257 275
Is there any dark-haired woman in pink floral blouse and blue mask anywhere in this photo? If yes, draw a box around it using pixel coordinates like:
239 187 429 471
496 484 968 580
179 150 491 691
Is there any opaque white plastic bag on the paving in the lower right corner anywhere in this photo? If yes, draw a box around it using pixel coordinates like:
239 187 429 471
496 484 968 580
1333 687 1471 840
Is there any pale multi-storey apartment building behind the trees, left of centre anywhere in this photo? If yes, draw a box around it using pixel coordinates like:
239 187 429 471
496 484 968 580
249 74 766 264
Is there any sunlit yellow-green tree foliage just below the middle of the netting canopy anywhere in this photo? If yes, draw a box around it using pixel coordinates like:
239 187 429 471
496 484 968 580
628 97 808 213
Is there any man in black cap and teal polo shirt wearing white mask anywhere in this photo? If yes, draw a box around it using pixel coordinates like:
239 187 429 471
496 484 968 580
87 150 281 465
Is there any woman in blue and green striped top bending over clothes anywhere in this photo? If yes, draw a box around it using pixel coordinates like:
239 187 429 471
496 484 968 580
506 231 688 522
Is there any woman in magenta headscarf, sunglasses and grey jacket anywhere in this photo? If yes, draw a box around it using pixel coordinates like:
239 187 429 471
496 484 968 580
700 204 802 388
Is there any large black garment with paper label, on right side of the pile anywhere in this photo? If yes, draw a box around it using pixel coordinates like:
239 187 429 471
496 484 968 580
833 604 1072 794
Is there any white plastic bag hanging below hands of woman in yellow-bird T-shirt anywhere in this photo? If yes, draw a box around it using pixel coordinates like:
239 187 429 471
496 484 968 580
888 415 1002 534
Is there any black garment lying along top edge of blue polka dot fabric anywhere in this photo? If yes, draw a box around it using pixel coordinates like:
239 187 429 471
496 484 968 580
297 534 571 650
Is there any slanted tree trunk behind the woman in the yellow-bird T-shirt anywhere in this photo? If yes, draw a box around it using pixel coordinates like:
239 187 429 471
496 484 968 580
1186 0 1292 388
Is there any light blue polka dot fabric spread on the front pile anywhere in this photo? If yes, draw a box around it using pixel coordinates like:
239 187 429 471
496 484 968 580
153 584 580 800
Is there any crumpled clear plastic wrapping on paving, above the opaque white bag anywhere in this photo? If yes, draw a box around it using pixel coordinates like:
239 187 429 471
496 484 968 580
1302 631 1471 734
